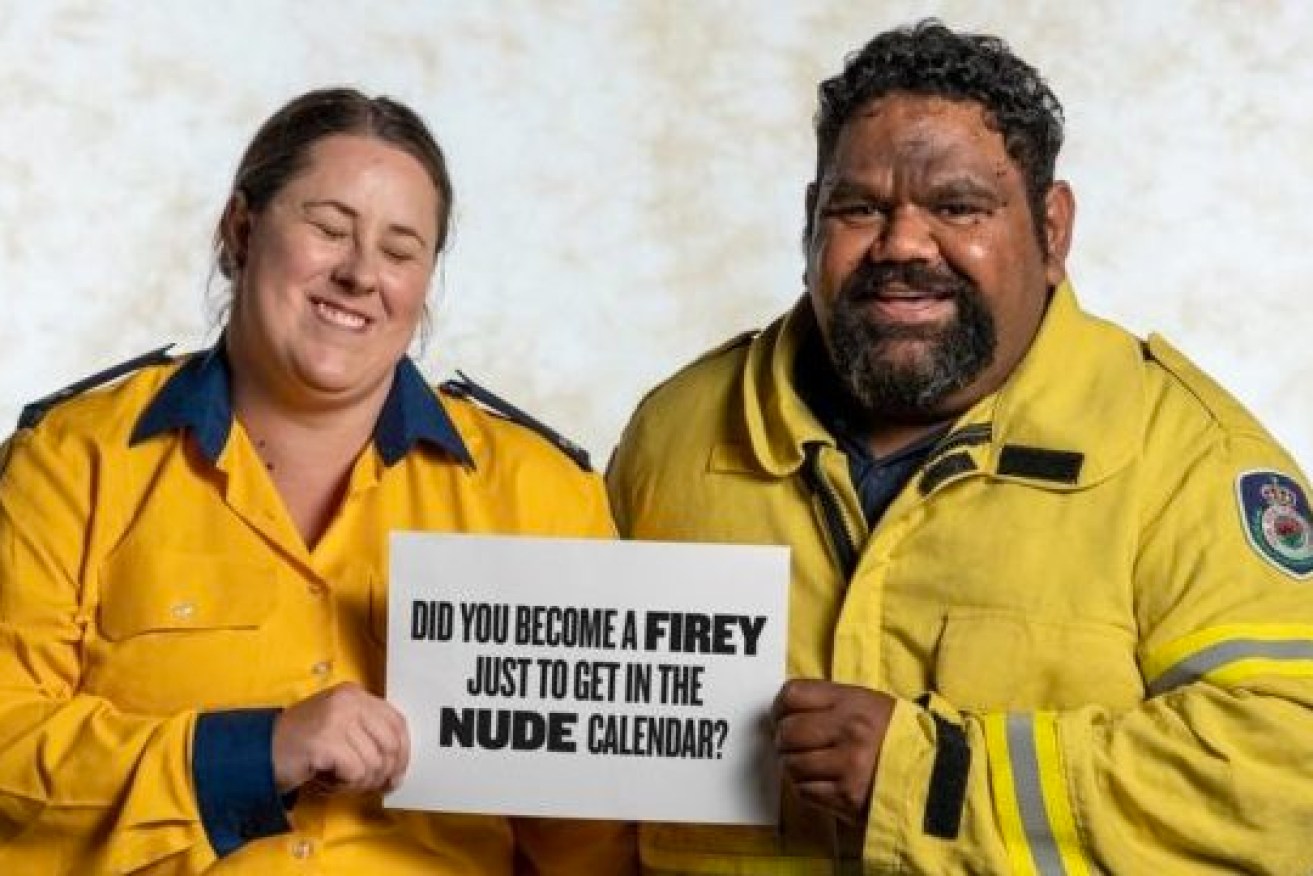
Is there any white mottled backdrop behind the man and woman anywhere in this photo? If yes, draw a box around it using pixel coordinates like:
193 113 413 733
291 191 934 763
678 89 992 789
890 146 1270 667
0 0 1313 469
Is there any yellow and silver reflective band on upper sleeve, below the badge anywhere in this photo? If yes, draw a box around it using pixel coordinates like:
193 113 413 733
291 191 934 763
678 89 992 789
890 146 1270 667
1144 624 1313 695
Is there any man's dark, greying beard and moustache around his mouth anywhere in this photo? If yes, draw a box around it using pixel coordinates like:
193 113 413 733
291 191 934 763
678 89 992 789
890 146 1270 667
826 261 997 418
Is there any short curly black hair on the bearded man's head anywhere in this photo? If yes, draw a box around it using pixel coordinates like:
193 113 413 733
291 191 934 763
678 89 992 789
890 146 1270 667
809 18 1062 242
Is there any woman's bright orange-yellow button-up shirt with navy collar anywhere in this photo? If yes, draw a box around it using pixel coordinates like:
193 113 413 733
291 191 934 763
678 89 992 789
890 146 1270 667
0 357 633 876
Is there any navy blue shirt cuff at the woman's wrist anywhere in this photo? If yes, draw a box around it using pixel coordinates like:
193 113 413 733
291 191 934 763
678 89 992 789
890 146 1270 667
192 709 291 858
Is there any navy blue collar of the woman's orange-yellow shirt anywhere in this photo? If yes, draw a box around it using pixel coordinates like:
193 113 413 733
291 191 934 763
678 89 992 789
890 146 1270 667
129 340 474 468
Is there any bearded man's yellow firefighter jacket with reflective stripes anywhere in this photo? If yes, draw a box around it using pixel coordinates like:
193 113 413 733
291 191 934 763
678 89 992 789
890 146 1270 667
608 284 1313 876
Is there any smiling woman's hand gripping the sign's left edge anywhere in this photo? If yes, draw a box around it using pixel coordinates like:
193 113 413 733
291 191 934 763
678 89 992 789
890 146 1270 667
273 683 410 793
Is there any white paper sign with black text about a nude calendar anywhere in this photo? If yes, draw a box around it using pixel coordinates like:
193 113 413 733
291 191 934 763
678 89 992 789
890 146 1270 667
386 532 789 825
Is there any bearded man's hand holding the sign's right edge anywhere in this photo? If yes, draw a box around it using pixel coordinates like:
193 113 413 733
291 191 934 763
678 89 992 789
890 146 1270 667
771 679 894 823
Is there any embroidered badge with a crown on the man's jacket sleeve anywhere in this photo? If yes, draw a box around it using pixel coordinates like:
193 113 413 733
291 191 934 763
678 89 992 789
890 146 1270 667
1236 470 1313 579
